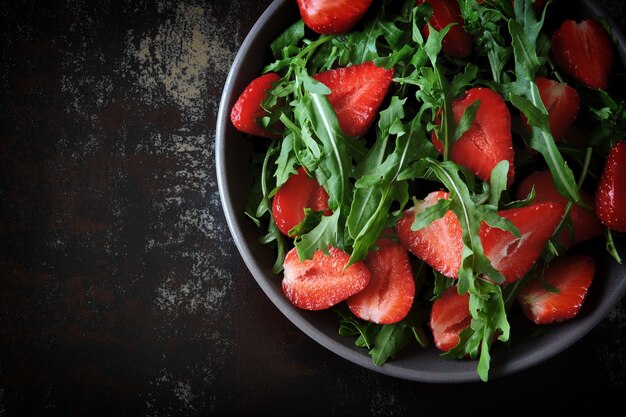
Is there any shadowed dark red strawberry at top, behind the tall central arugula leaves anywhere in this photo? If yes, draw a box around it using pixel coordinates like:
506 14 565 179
417 0 474 58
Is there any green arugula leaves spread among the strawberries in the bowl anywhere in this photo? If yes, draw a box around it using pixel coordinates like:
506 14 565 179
241 0 626 380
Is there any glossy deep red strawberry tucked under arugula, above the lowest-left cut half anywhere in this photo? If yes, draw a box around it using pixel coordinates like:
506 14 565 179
272 167 332 237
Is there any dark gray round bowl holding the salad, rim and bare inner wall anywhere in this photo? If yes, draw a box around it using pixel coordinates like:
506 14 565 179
216 0 626 383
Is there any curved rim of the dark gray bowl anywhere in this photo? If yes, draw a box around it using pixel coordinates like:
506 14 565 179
215 0 626 383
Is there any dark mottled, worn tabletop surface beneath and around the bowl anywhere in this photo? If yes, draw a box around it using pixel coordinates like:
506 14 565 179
0 0 626 417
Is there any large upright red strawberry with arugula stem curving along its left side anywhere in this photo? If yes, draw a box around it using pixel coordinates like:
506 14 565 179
433 87 514 185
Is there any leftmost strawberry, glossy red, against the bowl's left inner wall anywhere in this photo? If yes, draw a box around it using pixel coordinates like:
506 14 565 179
230 72 280 138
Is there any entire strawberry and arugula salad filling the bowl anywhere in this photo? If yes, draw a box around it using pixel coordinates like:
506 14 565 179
231 0 626 380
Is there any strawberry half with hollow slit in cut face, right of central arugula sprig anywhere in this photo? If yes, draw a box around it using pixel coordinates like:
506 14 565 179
480 203 564 284
